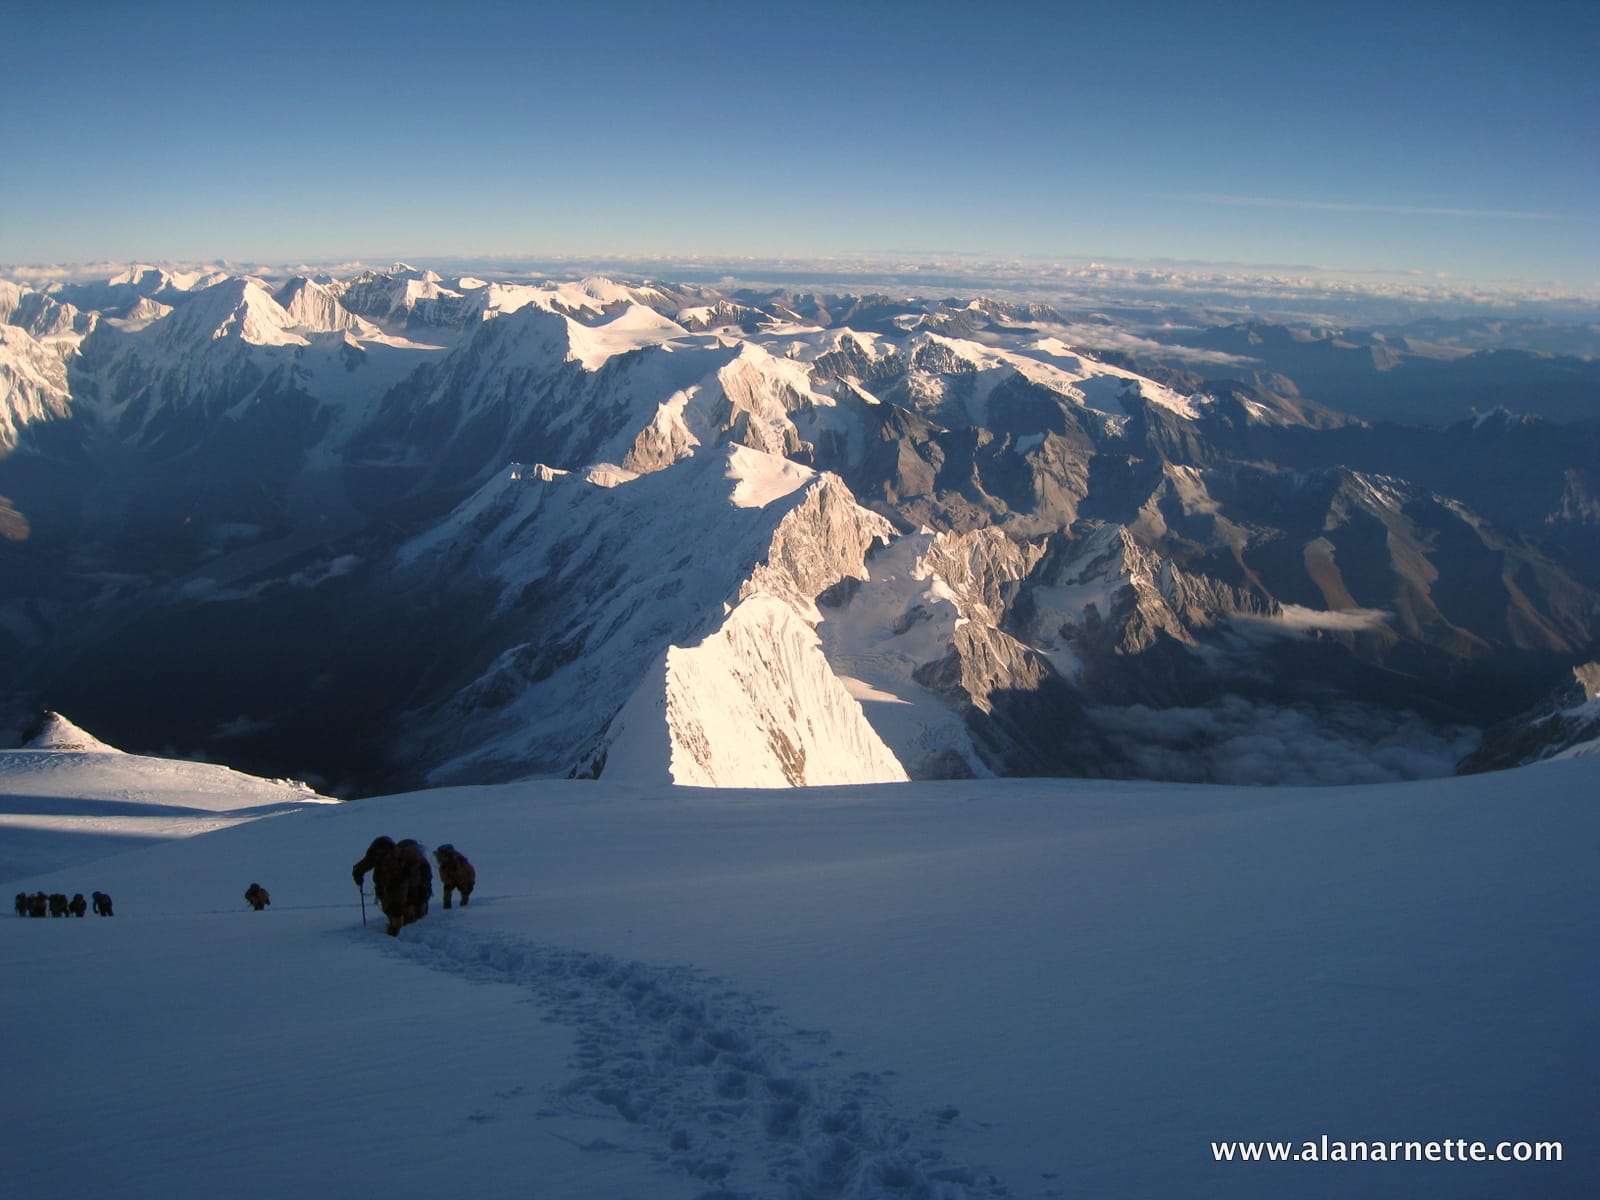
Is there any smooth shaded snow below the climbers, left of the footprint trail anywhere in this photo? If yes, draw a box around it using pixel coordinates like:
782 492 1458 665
0 885 694 1200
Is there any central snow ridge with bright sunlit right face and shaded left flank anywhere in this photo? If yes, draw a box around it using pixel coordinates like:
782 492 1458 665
402 446 904 786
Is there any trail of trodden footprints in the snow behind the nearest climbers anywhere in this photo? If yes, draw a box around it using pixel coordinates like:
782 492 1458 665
368 922 1008 1200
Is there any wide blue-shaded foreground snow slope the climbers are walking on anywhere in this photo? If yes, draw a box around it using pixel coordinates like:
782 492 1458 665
0 758 1600 1200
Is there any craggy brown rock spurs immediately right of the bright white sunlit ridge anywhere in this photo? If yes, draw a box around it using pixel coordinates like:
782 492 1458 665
822 526 1277 776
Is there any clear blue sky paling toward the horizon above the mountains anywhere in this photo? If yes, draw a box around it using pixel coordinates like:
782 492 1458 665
0 0 1600 290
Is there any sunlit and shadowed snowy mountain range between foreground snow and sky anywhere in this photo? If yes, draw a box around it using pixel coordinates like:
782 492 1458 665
0 264 1600 794
